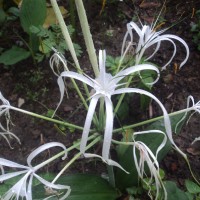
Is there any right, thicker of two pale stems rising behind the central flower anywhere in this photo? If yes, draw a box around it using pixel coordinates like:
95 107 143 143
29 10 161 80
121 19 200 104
75 0 99 77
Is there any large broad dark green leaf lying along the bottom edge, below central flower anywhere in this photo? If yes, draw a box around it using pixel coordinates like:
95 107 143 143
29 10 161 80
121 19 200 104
33 174 119 200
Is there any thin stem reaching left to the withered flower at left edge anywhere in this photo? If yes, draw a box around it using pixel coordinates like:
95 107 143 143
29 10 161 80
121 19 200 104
6 105 83 131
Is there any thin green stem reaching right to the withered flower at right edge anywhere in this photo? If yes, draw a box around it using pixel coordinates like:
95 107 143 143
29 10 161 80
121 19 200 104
113 107 193 133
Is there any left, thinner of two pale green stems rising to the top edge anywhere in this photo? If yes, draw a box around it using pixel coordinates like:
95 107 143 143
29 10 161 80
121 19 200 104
51 0 89 110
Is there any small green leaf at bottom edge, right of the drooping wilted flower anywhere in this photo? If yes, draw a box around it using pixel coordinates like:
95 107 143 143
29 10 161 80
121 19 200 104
164 181 188 200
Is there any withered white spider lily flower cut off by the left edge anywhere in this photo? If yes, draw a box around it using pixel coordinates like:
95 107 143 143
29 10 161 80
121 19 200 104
0 92 20 148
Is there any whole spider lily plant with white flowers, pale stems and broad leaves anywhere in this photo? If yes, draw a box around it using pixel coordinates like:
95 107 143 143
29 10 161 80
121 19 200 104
0 0 200 200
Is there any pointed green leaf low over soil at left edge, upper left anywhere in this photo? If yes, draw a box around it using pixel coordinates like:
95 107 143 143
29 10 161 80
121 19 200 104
0 46 30 65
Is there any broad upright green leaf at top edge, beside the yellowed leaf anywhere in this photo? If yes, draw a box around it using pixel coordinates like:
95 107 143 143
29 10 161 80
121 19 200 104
20 0 46 33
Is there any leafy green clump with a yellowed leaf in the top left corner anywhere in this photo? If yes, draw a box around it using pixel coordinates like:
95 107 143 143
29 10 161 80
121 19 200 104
0 0 82 66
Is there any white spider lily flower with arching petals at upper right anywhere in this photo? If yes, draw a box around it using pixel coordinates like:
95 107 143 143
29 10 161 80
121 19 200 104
121 22 189 70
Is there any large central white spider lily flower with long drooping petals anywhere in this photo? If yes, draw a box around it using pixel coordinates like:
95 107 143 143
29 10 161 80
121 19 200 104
52 50 184 167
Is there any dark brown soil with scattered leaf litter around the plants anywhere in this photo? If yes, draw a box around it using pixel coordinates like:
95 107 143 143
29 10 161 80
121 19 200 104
0 1 200 198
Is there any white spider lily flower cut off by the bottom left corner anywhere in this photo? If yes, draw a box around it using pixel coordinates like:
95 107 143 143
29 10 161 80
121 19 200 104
0 142 71 200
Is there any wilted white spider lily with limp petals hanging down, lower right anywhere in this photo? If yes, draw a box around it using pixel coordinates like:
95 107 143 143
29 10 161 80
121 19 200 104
133 130 167 200
